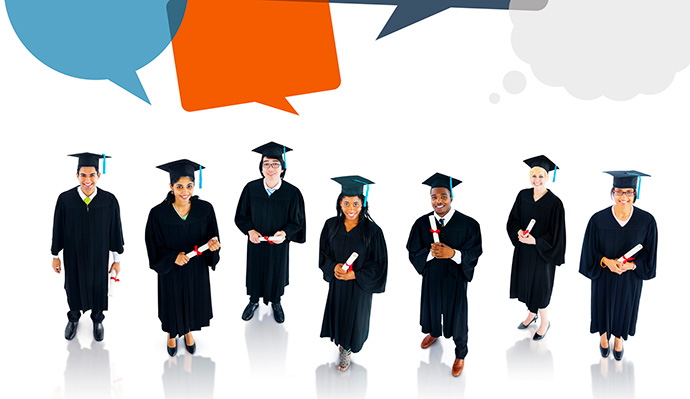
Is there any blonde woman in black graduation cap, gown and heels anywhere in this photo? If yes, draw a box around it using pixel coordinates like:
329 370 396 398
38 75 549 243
506 155 565 341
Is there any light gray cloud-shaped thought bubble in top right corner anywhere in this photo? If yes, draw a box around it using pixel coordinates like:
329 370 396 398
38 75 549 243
510 0 690 101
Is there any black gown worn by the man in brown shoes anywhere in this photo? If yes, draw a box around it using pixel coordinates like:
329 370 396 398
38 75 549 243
407 210 482 352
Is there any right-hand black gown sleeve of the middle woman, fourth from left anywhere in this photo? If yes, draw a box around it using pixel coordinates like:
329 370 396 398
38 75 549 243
354 227 388 294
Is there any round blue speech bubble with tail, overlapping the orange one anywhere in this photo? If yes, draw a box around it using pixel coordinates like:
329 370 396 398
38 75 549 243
6 0 187 104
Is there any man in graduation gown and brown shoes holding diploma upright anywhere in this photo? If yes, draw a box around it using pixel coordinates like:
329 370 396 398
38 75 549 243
407 173 482 377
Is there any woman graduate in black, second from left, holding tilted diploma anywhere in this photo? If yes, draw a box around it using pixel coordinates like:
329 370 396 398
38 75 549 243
146 159 220 356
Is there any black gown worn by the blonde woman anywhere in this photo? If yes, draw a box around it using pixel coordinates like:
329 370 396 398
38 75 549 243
506 188 565 313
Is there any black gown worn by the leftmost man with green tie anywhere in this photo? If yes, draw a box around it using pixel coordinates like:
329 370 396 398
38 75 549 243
51 187 124 311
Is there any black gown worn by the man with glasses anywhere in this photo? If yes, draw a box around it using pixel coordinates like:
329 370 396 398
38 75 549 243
235 179 306 304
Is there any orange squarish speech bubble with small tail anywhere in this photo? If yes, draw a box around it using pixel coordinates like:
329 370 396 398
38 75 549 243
172 0 340 114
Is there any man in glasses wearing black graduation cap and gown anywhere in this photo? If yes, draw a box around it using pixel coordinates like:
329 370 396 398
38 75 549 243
235 142 306 323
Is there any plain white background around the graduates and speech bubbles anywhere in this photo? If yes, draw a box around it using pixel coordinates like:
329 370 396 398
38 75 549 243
0 5 690 398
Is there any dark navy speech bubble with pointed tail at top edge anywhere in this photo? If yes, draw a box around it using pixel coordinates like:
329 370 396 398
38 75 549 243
278 0 548 40
